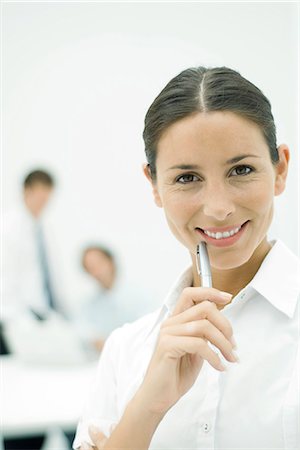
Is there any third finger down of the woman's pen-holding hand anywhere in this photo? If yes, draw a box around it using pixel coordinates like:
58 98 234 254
162 319 238 362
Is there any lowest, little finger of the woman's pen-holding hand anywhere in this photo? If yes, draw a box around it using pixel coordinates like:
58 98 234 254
165 336 226 372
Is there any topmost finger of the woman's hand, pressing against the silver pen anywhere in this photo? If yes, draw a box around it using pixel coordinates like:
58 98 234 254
172 287 232 316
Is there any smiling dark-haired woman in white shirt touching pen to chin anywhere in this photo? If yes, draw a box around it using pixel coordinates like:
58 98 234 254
74 67 300 450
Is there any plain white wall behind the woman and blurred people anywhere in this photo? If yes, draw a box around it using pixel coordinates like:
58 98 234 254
2 2 299 312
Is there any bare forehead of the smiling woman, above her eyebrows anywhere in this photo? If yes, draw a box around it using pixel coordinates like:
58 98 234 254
157 111 268 168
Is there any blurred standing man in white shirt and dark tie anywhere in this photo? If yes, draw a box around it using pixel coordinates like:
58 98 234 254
0 170 73 450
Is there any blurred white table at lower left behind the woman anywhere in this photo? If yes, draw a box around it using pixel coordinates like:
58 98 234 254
0 356 97 437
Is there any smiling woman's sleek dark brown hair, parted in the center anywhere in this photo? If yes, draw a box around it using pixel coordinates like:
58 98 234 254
143 66 279 180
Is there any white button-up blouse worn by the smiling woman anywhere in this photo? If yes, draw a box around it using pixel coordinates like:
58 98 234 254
73 241 300 450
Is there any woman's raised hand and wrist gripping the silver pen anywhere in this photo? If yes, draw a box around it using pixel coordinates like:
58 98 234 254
136 287 237 415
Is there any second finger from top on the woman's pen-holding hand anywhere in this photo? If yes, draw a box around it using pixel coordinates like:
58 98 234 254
161 300 234 344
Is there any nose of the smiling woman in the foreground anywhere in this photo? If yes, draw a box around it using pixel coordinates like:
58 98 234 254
202 183 235 222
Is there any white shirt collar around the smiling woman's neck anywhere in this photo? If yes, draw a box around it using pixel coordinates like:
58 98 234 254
163 240 300 321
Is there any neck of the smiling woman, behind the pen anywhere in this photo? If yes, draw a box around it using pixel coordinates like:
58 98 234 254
193 239 271 297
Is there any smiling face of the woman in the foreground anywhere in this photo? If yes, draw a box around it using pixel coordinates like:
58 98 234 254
148 112 289 269
